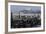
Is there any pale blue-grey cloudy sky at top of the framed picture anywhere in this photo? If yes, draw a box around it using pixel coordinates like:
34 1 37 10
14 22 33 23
10 5 41 13
